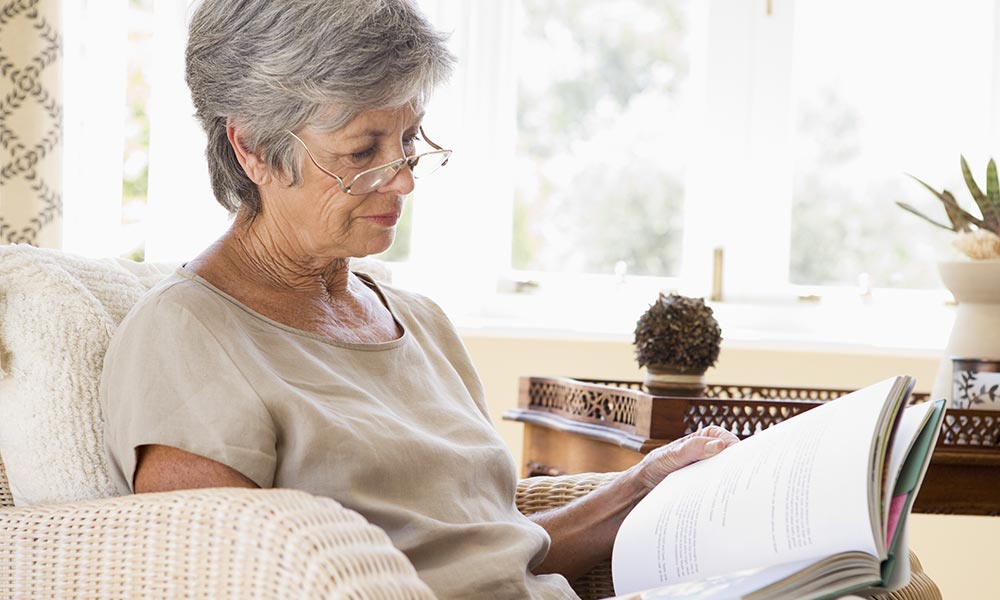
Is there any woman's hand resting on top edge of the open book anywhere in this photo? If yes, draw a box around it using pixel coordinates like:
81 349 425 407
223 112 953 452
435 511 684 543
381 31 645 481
626 425 740 499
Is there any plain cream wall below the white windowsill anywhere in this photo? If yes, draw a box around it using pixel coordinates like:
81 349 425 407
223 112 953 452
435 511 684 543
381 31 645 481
463 331 1000 600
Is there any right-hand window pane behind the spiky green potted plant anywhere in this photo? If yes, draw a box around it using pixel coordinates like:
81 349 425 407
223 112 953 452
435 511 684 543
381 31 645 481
790 0 1000 287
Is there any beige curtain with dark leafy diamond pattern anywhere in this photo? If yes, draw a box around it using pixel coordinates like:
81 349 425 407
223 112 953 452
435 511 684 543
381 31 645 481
0 0 62 248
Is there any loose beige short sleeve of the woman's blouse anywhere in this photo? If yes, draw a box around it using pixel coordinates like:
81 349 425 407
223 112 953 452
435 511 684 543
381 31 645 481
101 295 277 493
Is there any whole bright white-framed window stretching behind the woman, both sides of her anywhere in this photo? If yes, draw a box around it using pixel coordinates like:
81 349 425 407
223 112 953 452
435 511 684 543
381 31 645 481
64 0 1000 342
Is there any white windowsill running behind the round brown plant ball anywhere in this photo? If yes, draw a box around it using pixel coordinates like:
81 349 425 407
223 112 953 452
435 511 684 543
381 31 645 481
446 294 955 356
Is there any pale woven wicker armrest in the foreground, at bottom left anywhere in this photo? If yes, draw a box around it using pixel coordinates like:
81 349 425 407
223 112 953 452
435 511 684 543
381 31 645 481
0 488 434 599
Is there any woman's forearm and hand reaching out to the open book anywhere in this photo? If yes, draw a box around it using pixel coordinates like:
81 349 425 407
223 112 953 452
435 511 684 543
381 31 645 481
529 425 739 581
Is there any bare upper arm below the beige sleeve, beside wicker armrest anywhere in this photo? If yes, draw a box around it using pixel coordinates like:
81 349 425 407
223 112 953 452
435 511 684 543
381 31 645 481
134 445 258 494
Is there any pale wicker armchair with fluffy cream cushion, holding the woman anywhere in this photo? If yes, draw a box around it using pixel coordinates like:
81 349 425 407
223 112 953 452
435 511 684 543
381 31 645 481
0 246 940 600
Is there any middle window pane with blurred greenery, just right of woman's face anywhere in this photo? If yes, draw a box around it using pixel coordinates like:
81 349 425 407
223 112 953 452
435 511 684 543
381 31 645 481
511 0 691 276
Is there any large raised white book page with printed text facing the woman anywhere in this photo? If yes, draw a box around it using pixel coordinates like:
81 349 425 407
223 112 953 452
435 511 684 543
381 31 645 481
612 378 903 594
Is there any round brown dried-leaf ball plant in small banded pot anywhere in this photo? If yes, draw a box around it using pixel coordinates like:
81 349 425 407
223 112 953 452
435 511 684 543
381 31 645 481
635 293 722 397
